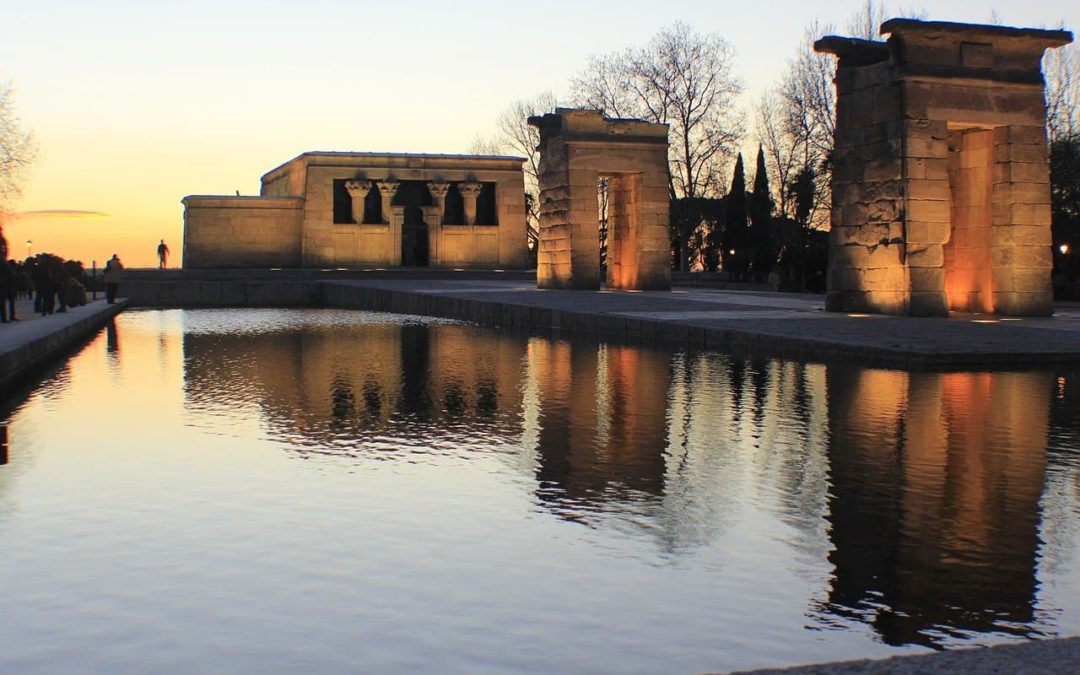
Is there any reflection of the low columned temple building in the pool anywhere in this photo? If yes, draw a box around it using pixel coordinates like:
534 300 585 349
184 322 525 454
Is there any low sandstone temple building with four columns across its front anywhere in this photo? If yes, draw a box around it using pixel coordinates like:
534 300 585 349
183 152 528 269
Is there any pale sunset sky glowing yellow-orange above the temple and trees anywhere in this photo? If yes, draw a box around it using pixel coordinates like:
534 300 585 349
0 0 1080 267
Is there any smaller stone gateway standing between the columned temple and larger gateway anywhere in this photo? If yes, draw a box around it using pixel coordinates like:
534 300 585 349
529 108 671 291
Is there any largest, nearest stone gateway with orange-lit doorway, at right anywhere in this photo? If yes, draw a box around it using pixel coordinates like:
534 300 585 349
814 18 1072 315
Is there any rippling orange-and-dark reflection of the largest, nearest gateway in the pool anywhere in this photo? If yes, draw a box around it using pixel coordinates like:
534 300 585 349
827 367 1053 646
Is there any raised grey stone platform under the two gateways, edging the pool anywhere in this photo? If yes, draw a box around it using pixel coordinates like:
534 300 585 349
324 279 1080 369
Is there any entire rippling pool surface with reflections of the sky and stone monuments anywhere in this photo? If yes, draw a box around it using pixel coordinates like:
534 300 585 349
0 310 1080 673
